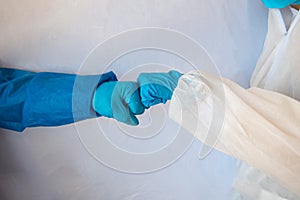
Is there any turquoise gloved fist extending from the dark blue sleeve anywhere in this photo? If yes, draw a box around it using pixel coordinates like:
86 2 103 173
93 81 145 125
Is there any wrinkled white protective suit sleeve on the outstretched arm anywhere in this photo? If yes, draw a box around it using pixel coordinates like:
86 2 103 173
169 71 300 196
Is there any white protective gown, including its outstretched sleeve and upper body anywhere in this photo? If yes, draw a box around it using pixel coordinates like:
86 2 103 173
169 9 300 196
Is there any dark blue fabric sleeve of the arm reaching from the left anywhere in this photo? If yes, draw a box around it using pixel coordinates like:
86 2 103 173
0 68 117 131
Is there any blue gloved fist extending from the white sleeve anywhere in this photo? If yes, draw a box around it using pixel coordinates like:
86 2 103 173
138 70 182 108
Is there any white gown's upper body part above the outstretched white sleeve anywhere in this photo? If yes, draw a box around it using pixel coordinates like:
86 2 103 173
251 8 300 100
